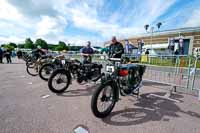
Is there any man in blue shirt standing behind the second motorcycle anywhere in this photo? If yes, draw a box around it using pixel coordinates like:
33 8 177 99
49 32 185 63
80 41 94 64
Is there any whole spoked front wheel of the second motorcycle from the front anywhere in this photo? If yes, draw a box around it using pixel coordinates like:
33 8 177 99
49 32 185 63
48 69 71 93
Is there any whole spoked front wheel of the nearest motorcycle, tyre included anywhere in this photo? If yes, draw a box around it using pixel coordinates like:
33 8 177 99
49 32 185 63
91 84 116 118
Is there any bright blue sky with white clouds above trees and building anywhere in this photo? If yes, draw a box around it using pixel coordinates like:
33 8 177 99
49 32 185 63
0 0 200 45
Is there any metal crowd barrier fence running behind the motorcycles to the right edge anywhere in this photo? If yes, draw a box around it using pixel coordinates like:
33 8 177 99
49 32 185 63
62 54 200 100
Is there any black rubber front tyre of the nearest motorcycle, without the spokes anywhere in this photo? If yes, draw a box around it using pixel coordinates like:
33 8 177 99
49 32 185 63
91 83 116 118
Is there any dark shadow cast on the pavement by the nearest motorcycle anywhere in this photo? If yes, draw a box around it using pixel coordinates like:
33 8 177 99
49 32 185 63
102 93 200 126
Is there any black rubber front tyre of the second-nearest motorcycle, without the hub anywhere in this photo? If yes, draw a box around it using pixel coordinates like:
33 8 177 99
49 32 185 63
48 69 71 94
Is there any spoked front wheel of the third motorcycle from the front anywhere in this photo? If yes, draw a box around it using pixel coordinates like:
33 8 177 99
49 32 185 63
39 64 54 81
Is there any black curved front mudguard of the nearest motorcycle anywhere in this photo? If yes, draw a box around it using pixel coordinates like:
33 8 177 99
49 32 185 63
101 79 119 102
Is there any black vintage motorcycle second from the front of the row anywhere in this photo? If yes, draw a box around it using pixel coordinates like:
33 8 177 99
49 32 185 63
48 60 102 93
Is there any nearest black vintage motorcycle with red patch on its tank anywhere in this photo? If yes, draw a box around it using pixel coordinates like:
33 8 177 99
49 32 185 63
91 59 145 118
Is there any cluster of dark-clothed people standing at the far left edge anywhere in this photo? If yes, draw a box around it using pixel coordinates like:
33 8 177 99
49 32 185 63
0 47 12 63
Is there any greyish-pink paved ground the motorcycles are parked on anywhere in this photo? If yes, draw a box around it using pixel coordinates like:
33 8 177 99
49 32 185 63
0 58 200 133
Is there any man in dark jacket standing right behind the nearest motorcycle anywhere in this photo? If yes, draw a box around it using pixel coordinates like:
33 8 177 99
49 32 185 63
108 36 124 58
